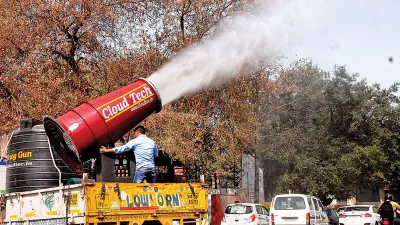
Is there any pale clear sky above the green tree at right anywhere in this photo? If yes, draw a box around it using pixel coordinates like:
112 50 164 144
285 0 400 88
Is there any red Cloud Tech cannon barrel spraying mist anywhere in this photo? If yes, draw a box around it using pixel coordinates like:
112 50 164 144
44 79 162 174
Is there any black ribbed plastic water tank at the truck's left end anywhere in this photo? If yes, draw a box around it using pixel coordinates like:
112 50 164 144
6 119 90 193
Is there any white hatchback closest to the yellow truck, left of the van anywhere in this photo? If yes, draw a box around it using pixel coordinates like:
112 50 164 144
221 203 269 225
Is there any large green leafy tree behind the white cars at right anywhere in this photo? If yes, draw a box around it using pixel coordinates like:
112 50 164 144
259 59 400 199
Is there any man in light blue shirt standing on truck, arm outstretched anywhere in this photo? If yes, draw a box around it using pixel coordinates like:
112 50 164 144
100 125 158 183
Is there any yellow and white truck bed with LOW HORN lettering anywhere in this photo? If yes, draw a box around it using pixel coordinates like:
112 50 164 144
0 182 209 225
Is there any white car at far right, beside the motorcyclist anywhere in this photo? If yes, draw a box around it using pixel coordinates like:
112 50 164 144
339 205 381 225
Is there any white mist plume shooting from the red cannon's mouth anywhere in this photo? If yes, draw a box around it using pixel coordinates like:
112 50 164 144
148 0 325 105
